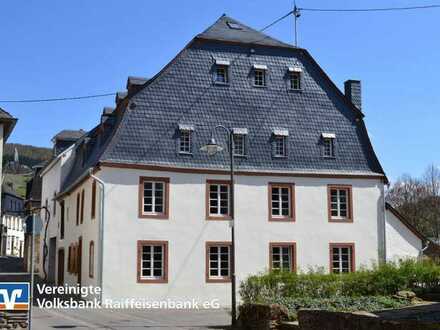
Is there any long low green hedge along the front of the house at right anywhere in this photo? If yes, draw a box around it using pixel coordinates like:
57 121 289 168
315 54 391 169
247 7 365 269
240 260 440 303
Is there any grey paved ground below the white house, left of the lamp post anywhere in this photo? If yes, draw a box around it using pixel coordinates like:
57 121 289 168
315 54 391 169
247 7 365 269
32 308 230 330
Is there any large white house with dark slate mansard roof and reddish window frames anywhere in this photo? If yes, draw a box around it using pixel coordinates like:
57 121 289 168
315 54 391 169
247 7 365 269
38 16 421 306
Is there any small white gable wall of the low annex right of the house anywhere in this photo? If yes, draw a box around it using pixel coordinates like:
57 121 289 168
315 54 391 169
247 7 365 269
386 210 423 261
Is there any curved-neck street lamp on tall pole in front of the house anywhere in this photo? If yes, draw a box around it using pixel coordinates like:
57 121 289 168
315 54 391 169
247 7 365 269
200 125 237 325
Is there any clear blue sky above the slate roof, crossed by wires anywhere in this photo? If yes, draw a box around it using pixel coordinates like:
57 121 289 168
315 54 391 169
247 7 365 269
0 0 440 180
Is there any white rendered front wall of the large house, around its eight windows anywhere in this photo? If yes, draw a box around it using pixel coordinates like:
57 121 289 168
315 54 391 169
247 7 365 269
98 168 383 305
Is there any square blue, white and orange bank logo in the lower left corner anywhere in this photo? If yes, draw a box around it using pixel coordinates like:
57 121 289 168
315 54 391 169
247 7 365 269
0 282 29 311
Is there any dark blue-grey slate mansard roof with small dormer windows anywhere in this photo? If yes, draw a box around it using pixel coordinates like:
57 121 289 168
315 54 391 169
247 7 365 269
57 16 384 195
